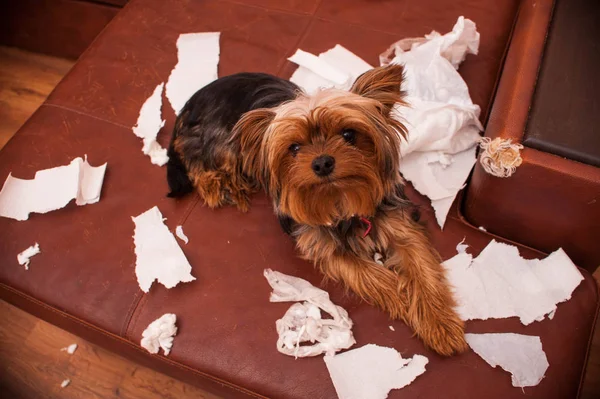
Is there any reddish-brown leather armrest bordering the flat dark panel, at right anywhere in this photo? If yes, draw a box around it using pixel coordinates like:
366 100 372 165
463 0 600 271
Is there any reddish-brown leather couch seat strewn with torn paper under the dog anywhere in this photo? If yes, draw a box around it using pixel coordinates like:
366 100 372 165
0 0 598 399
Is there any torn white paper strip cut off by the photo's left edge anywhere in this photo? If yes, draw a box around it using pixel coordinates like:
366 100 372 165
0 157 106 220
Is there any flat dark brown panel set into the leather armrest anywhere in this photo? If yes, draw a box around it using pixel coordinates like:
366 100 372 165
523 0 600 167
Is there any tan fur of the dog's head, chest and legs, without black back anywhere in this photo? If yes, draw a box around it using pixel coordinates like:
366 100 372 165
217 65 467 355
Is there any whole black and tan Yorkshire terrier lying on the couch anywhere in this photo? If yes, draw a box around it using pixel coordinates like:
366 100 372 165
167 65 467 356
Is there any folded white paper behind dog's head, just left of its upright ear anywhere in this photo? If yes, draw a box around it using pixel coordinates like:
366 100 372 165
288 44 373 94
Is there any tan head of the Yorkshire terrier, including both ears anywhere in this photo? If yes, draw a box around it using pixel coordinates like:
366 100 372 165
234 65 405 226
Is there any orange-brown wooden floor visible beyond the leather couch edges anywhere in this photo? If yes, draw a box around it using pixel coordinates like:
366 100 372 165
0 46 600 399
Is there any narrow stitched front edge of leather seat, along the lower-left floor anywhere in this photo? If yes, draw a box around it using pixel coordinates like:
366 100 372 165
0 283 268 399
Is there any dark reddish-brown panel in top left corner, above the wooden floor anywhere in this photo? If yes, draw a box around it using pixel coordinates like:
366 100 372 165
0 0 120 59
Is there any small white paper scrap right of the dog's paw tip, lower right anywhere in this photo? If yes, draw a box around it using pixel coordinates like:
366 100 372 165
465 334 549 388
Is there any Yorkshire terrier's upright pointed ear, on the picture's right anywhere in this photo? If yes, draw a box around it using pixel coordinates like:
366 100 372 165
350 64 404 116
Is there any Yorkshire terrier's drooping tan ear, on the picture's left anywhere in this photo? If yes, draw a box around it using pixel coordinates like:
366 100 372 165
232 108 275 186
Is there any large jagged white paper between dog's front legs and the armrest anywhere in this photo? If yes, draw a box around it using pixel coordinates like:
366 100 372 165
442 240 583 325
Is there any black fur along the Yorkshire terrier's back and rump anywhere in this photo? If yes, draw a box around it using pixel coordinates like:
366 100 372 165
167 73 300 197
